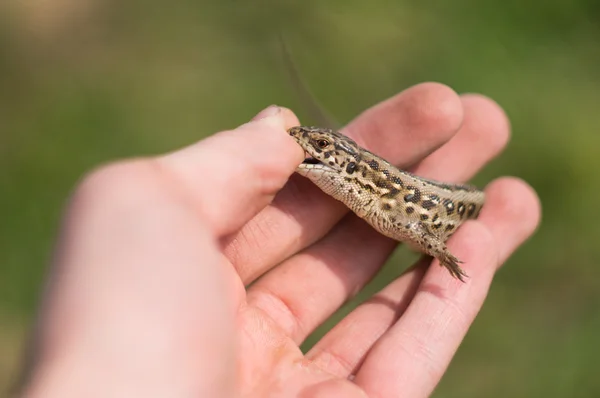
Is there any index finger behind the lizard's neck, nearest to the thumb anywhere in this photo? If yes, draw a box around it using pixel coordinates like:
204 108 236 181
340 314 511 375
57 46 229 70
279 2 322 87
225 83 462 283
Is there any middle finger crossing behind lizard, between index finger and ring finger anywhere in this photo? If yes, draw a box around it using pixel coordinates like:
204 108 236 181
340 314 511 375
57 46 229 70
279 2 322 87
248 97 509 343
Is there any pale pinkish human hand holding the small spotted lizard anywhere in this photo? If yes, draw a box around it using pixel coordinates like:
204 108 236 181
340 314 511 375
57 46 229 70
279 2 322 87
25 83 540 398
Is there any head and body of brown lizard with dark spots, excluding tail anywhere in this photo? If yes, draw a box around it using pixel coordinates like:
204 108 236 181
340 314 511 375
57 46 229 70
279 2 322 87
288 126 485 282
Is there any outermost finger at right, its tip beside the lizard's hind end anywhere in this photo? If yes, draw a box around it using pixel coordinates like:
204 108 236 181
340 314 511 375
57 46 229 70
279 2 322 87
354 179 540 396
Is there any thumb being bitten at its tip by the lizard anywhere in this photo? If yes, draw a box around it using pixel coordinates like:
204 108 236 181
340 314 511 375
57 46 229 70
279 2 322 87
157 107 303 236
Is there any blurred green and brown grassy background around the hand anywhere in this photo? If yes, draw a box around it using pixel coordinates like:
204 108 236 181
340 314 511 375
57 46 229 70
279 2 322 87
0 0 600 397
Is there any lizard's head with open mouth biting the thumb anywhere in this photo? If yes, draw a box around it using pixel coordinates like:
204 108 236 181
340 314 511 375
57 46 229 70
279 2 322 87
288 126 360 173
